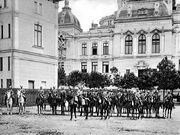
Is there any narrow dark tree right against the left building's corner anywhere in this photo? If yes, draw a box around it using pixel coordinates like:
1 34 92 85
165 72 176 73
58 68 66 87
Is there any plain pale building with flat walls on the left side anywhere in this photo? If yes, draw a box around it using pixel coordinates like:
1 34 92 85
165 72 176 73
0 0 58 88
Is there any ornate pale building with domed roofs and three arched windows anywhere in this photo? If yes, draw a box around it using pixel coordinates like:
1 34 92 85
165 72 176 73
58 0 180 75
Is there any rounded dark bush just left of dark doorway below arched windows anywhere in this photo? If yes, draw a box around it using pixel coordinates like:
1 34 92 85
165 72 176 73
120 73 138 89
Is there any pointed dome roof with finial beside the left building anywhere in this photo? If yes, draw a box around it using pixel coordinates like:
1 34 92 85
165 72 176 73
58 0 81 28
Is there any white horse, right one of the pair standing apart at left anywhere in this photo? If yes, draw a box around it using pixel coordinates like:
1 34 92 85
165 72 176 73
17 91 25 114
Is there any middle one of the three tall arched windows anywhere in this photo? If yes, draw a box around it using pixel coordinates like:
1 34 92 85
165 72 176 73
138 34 146 54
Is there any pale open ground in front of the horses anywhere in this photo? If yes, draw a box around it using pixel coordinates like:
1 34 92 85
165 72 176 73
0 106 180 135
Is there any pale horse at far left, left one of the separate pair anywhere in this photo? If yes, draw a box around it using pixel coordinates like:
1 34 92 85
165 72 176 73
5 91 13 115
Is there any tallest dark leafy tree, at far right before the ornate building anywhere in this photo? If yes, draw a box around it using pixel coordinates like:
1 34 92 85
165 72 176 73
157 57 178 90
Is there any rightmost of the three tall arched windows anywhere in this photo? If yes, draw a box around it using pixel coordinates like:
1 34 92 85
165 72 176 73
152 33 160 53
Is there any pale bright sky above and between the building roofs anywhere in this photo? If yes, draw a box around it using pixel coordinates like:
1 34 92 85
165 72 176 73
59 0 180 31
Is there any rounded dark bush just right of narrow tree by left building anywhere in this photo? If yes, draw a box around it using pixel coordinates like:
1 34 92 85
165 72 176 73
67 71 82 86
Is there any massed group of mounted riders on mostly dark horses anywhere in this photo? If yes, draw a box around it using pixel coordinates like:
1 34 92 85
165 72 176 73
36 90 174 119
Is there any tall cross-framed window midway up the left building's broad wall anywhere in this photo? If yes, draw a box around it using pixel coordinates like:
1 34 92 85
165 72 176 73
34 24 42 47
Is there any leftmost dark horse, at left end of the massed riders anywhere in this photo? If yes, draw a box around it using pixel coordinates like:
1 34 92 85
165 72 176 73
36 93 44 114
